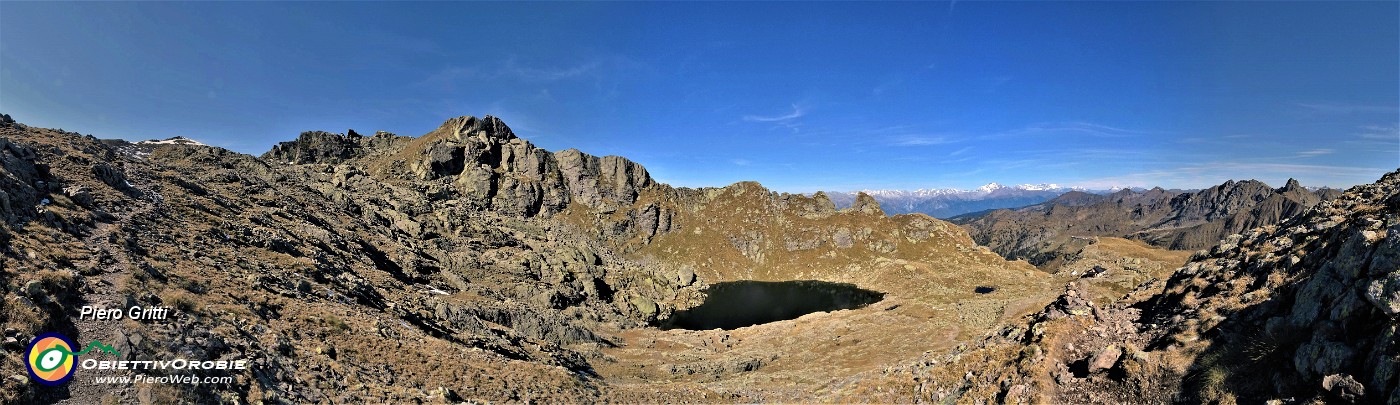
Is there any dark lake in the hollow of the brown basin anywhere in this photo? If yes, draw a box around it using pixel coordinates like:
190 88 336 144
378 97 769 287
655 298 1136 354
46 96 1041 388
661 280 885 331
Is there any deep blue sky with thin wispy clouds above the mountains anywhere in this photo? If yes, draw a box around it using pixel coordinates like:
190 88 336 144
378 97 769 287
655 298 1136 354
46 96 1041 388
0 1 1400 192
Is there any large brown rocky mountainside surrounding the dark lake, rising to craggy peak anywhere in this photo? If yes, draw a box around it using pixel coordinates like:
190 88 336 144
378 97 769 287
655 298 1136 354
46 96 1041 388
0 116 1054 404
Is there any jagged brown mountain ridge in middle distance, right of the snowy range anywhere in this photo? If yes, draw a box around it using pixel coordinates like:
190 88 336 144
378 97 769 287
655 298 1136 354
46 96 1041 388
952 179 1338 265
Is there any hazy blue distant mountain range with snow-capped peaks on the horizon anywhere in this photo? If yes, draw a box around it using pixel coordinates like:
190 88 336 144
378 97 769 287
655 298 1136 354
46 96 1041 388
826 182 1116 219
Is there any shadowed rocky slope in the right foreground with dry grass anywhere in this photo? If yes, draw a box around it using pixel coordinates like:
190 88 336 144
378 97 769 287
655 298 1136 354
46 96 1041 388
848 166 1400 404
